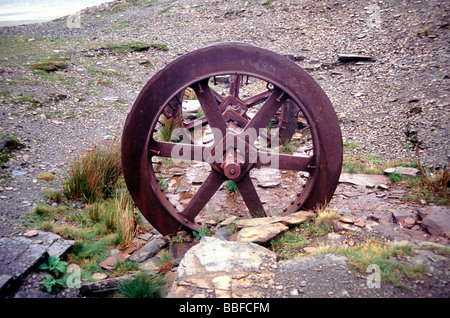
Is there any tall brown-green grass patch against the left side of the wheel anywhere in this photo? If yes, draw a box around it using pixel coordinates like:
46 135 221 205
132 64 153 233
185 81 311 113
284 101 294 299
26 139 153 279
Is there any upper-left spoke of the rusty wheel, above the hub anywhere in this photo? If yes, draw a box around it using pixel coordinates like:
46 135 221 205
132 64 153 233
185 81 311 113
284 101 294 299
191 79 227 136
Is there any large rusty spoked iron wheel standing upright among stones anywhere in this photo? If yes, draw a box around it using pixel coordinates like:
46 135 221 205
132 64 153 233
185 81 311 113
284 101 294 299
122 42 342 235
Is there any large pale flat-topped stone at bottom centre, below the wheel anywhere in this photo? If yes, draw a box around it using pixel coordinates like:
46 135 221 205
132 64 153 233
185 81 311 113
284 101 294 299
167 237 277 298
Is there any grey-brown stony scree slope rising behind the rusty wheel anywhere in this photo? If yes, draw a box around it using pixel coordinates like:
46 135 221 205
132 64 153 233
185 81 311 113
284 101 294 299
0 0 450 297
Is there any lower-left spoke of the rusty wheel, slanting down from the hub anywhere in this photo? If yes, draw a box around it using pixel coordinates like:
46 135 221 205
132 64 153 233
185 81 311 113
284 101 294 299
181 169 225 221
